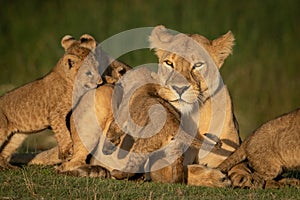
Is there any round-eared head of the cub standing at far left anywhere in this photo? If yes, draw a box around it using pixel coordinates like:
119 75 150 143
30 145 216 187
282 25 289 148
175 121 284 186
54 34 102 89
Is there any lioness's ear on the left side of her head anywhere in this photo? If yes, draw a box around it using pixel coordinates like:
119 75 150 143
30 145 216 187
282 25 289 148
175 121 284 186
149 25 173 57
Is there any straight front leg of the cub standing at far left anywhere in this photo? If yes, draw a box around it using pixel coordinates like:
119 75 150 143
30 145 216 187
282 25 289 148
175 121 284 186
50 112 73 160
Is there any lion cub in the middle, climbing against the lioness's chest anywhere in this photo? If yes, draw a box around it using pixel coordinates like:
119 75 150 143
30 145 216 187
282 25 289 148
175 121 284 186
98 68 224 183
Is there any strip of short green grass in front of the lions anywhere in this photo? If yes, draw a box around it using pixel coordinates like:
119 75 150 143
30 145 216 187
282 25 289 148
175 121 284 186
0 166 300 200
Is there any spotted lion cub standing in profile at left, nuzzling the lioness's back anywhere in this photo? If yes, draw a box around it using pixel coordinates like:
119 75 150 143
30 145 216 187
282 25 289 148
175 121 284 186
0 34 102 168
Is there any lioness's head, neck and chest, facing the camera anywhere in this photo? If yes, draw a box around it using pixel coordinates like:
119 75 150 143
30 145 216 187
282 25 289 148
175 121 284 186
149 26 240 167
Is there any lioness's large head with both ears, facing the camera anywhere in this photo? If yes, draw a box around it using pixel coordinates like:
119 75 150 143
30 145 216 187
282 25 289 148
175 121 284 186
149 26 234 113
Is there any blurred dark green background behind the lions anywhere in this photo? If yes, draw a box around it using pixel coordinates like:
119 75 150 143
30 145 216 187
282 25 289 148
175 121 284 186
0 0 300 152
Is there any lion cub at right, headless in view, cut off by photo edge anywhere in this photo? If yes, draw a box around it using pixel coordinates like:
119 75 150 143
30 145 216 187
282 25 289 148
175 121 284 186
218 108 300 188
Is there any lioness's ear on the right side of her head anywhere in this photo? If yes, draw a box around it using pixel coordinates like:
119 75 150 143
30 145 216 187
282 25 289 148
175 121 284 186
212 31 234 68
